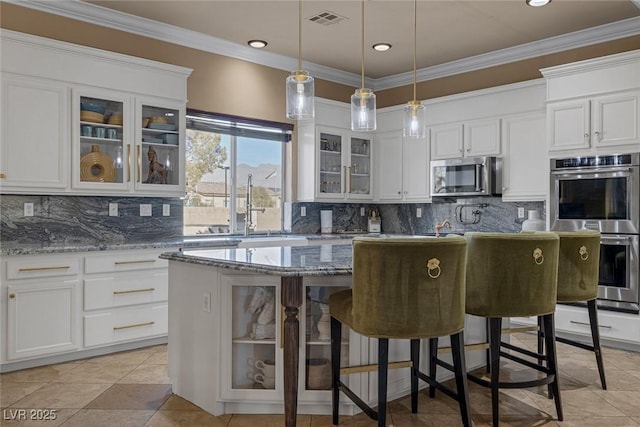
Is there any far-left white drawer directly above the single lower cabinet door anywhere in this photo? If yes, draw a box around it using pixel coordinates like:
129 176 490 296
7 257 80 280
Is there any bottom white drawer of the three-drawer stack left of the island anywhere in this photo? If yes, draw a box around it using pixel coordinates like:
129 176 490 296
84 304 168 347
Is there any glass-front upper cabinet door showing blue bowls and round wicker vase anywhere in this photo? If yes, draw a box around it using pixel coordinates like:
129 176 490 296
72 90 132 190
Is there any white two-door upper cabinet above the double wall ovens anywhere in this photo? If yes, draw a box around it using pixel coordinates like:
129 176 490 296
541 50 640 157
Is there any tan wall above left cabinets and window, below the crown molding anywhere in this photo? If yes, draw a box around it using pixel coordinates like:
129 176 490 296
0 3 353 122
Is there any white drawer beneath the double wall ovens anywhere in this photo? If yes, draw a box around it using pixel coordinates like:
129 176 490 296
556 306 640 343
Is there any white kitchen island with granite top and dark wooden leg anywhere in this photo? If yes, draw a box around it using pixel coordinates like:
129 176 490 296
161 244 484 426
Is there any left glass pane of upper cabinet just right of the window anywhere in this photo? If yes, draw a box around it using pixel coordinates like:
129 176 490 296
320 132 344 196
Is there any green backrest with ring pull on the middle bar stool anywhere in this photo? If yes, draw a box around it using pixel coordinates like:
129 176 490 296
465 232 559 317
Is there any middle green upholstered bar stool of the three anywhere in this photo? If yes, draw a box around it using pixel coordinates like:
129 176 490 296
465 232 563 426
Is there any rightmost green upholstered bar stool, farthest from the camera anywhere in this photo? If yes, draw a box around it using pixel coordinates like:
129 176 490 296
538 230 607 390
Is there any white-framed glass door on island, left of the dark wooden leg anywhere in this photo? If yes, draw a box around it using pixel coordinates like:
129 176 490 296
220 275 283 400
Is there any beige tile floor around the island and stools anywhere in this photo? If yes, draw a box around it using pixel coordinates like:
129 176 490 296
0 335 640 427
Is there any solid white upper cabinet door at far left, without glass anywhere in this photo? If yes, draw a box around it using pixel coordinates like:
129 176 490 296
0 72 70 191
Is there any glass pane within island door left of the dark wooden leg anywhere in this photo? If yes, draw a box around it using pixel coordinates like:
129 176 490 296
230 284 280 391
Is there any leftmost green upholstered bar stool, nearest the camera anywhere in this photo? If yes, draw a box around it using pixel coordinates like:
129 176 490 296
329 236 471 427
